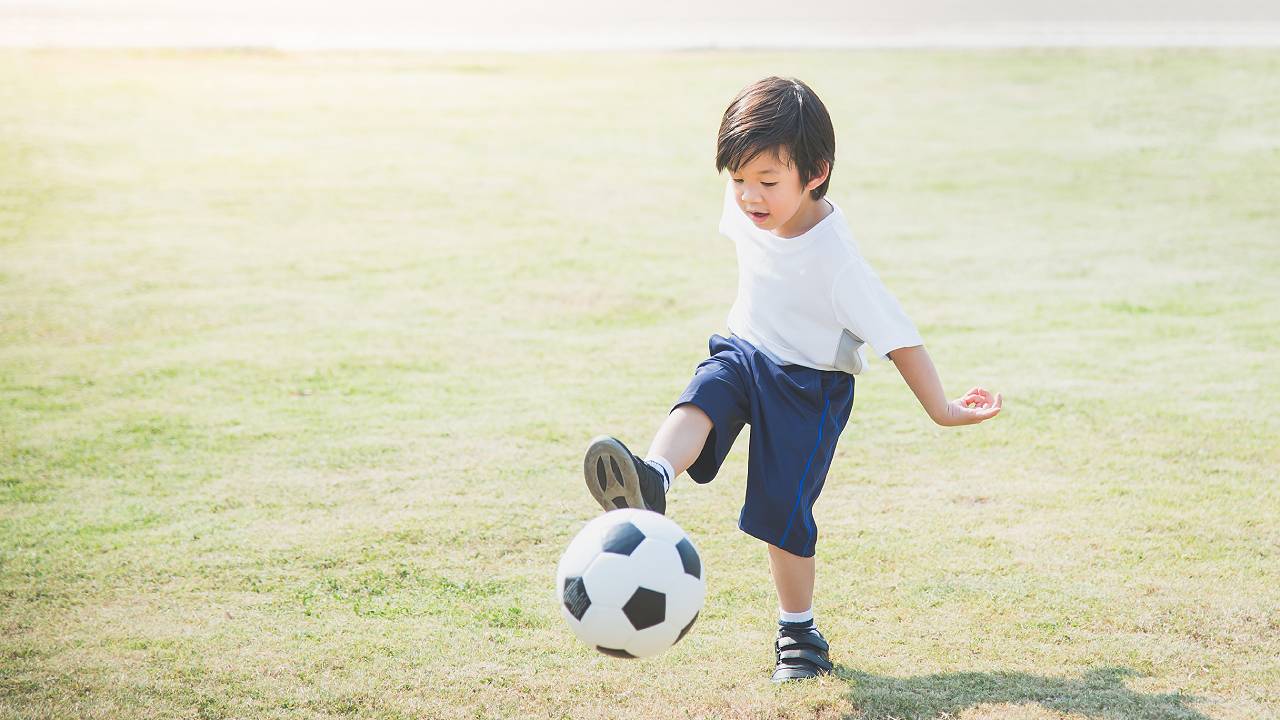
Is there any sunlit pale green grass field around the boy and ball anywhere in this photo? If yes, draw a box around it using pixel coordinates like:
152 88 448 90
0 50 1280 720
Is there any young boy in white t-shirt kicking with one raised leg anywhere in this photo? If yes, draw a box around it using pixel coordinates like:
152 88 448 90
584 77 1001 682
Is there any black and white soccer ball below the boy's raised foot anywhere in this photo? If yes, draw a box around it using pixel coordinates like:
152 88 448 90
556 509 707 657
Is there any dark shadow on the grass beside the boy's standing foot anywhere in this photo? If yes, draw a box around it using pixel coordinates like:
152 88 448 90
836 665 1210 720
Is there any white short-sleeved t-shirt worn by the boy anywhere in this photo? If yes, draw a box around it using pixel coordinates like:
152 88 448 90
719 179 924 374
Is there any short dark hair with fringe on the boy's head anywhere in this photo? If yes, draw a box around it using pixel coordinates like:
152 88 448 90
716 77 836 200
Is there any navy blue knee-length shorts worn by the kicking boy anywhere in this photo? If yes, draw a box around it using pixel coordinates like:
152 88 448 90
672 334 854 557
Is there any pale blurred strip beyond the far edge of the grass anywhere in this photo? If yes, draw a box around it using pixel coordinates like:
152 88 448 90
0 0 1280 50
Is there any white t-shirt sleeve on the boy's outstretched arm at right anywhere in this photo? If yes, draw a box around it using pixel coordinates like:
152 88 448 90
831 258 924 359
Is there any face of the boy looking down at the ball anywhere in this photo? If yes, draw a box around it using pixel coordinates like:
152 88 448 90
732 149 827 237
